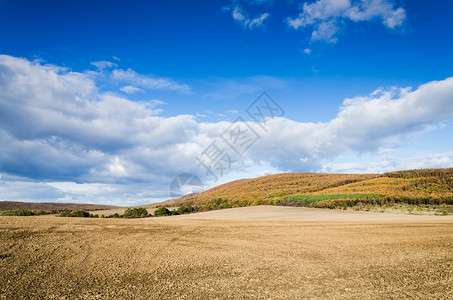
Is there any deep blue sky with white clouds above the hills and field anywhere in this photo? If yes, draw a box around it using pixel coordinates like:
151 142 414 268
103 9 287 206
0 0 453 206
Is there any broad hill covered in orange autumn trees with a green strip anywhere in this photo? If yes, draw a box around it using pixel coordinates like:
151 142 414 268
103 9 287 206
172 168 453 211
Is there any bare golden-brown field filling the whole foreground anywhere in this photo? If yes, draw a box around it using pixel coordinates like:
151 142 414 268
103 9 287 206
0 207 453 299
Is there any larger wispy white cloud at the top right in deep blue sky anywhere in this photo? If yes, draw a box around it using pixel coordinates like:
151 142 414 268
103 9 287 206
287 0 406 43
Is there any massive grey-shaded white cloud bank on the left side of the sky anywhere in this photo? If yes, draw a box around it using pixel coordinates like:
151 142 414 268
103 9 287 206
0 56 198 181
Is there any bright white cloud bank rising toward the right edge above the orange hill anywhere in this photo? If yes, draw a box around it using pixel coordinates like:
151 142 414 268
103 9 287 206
251 77 453 170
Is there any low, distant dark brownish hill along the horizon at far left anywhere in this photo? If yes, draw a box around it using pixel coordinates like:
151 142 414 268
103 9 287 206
0 201 118 213
